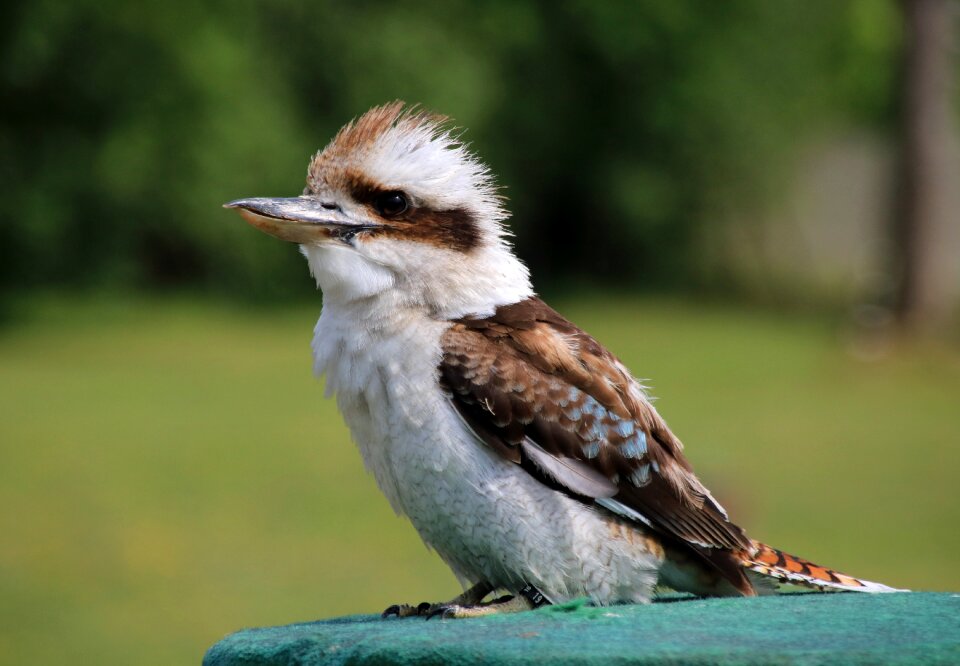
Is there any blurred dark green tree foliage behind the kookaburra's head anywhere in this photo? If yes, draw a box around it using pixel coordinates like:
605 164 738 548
0 0 899 297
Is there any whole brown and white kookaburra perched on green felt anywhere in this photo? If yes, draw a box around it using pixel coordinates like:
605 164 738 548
224 101 898 618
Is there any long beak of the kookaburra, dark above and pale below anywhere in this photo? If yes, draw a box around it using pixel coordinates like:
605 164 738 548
223 197 374 243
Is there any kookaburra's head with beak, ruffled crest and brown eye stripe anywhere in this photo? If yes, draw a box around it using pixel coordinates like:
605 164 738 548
226 102 532 317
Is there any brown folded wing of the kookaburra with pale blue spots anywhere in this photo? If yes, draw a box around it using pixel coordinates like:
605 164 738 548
440 299 751 559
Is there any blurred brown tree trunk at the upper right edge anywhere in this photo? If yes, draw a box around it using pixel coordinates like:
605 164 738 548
891 0 960 332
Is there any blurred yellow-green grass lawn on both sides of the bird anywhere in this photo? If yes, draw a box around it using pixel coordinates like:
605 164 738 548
0 295 960 664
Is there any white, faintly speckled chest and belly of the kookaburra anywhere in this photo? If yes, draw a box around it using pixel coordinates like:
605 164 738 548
313 298 659 602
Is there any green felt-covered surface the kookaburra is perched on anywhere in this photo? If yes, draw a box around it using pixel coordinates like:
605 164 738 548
203 592 960 666
